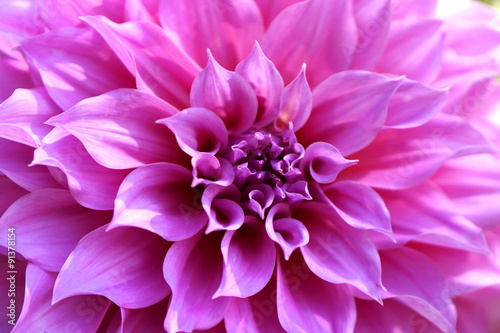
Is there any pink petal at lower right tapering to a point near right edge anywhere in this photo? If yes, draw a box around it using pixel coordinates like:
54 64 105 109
381 182 488 253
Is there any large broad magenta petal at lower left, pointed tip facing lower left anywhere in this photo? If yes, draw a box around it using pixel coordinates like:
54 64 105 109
53 226 170 309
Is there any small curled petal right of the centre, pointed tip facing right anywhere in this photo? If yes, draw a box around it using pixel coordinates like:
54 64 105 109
300 142 357 184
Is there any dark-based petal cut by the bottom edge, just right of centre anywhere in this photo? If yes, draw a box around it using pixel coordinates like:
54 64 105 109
277 253 356 333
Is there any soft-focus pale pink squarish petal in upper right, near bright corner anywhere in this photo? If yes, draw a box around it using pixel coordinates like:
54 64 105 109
375 19 444 83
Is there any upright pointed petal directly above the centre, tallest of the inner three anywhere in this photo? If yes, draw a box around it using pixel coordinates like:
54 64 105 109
235 42 284 127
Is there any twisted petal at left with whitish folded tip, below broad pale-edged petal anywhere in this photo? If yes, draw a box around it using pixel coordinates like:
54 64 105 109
32 127 130 210
